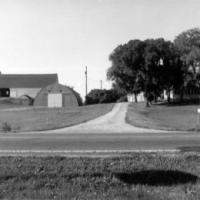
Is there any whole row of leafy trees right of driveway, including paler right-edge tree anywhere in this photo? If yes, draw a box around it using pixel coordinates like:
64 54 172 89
107 28 200 106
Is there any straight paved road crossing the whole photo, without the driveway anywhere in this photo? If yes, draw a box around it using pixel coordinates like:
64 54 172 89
0 133 200 154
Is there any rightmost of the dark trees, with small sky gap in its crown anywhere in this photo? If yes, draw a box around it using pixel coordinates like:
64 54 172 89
148 38 183 103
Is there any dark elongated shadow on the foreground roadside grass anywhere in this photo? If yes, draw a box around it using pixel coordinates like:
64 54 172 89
114 170 198 186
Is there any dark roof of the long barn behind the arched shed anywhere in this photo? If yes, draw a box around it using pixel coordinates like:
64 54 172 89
0 74 58 88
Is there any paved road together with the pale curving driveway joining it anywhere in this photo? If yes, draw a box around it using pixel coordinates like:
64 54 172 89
0 104 200 155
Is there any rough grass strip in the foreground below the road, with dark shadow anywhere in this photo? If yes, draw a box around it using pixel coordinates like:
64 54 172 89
0 154 200 200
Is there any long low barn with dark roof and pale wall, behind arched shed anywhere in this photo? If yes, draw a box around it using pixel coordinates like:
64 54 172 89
0 74 58 98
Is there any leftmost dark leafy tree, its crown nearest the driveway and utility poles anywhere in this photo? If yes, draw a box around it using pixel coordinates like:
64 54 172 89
107 40 143 101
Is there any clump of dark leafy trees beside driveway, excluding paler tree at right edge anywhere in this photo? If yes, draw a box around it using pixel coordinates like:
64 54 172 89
107 38 181 106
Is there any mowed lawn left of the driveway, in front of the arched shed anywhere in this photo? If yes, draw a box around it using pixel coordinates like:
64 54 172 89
0 104 114 132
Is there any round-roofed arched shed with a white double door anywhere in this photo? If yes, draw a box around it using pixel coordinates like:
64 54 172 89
34 83 79 107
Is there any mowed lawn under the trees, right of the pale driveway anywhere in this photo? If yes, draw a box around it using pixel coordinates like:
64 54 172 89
126 103 200 131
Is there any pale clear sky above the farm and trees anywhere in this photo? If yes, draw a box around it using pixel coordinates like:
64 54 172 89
0 0 200 97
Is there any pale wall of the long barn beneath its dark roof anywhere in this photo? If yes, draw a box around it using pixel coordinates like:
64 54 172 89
10 88 41 98
